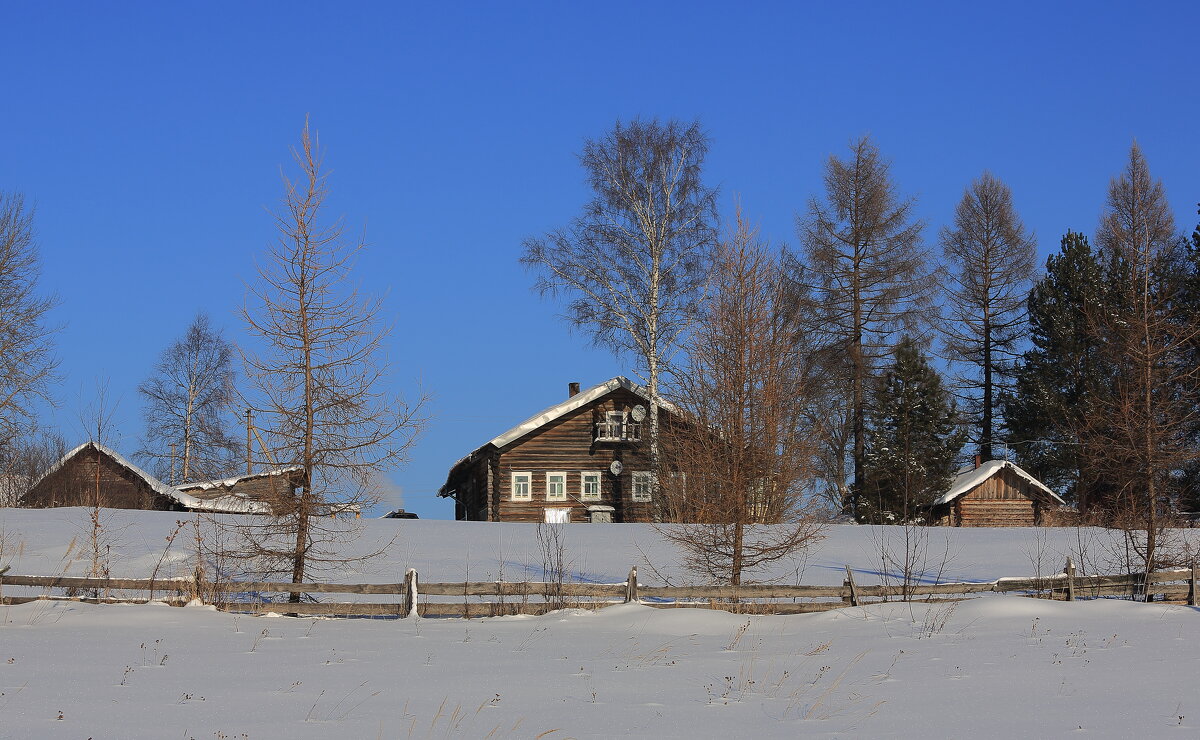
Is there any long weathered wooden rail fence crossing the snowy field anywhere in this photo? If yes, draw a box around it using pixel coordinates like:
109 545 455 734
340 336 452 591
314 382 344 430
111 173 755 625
0 560 1198 618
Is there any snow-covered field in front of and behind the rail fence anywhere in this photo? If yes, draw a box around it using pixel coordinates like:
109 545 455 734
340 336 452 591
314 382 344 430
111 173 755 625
0 509 1200 739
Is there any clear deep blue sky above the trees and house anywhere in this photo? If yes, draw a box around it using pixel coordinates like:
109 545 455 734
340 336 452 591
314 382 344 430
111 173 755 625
0 2 1200 518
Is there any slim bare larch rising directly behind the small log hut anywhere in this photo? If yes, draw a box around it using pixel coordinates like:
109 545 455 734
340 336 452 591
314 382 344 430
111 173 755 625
941 172 1037 462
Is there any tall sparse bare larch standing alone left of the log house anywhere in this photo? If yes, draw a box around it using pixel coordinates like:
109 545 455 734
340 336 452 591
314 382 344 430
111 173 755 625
238 121 425 601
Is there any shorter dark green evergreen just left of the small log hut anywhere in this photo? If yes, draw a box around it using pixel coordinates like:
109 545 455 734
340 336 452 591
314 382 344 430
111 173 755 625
858 337 965 524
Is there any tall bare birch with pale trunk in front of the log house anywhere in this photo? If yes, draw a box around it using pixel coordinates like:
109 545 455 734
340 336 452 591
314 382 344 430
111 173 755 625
521 120 716 501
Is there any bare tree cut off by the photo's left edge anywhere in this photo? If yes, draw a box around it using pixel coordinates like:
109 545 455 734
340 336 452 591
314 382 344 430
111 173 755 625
0 191 58 449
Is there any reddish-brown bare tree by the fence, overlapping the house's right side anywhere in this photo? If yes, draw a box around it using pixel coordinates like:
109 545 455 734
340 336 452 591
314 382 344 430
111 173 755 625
659 213 824 585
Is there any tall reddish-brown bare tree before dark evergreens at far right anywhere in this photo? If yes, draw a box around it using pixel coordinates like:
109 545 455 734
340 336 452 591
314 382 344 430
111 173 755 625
1086 143 1200 571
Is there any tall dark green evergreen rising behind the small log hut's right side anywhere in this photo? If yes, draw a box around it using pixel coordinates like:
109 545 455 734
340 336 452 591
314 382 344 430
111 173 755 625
1002 231 1110 501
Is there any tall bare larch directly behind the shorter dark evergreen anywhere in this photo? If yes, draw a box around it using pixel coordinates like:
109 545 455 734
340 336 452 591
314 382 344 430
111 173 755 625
798 137 935 513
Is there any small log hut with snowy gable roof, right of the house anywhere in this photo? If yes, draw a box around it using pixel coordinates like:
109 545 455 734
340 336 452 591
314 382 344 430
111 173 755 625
931 459 1064 527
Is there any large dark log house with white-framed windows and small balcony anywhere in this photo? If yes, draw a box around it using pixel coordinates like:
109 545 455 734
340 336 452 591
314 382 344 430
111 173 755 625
438 377 674 523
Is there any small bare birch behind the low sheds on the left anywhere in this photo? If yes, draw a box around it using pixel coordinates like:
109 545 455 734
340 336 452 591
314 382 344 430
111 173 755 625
138 313 241 486
